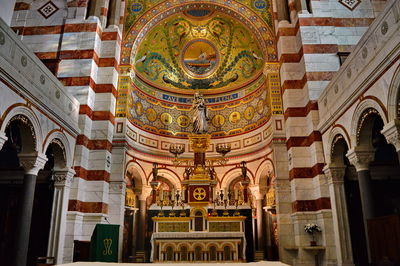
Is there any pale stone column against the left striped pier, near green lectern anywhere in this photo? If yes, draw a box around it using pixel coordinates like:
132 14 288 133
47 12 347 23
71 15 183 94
47 168 75 264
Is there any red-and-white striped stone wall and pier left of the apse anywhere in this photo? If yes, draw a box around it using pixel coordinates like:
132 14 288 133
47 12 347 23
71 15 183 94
11 0 121 262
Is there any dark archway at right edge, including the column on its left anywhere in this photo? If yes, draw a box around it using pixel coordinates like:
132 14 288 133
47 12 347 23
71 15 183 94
347 108 400 265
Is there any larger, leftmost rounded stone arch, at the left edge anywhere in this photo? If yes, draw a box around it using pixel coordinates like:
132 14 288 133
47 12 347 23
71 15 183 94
0 105 43 152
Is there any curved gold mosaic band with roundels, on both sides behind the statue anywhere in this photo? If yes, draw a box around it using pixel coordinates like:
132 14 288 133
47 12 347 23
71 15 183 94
127 78 271 137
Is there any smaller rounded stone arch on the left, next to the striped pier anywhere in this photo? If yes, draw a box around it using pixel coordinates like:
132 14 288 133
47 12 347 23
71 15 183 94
42 130 73 168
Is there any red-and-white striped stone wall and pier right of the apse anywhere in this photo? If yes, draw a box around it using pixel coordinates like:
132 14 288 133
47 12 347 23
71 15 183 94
274 0 381 260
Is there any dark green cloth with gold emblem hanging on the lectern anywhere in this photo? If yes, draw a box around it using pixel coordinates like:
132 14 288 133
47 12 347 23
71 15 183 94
90 224 119 262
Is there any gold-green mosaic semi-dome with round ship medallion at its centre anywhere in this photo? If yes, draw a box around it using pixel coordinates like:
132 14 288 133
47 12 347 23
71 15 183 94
131 9 265 92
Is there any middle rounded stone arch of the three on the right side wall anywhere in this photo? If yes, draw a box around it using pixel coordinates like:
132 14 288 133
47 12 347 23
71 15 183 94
350 98 388 146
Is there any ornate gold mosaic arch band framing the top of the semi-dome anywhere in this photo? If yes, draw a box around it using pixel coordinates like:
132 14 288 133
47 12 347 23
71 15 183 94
121 0 277 65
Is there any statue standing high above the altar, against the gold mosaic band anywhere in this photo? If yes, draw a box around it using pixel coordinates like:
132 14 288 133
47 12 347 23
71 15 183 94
192 92 209 134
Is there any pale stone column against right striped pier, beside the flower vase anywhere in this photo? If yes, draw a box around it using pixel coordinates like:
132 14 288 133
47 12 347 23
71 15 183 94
323 165 354 266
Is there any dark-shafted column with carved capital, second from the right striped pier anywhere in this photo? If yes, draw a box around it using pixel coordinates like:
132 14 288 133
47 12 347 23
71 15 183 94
346 147 375 262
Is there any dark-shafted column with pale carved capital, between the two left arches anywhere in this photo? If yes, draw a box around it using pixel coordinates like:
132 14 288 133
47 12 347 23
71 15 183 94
13 152 47 266
